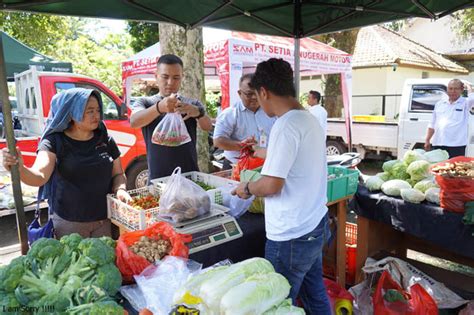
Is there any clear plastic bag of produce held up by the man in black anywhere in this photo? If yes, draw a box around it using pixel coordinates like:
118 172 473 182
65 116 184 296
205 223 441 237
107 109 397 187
151 113 191 147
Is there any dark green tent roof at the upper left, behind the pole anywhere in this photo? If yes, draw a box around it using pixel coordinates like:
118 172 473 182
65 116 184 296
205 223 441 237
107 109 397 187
0 32 72 80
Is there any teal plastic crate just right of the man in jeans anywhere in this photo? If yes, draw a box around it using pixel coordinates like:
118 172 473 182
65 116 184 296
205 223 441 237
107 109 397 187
327 166 359 202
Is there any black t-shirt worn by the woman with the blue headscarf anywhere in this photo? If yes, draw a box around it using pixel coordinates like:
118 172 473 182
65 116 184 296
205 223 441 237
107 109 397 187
38 131 120 222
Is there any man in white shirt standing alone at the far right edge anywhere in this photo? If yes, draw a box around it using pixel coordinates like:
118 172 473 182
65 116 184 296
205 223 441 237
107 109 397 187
425 79 474 158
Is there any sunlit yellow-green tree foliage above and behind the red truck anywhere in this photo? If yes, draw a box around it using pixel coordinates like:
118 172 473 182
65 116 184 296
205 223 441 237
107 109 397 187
0 12 133 94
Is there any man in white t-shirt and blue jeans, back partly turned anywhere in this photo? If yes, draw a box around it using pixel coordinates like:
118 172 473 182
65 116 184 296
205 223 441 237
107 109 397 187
233 58 331 314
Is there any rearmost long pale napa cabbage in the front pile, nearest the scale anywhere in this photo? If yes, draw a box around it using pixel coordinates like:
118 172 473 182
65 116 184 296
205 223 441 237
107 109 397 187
199 257 274 314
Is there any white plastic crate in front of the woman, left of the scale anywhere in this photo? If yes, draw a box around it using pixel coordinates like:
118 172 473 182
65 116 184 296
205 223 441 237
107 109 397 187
107 186 162 231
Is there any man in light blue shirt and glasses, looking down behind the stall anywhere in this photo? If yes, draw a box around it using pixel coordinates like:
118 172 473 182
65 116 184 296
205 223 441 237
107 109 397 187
214 73 276 170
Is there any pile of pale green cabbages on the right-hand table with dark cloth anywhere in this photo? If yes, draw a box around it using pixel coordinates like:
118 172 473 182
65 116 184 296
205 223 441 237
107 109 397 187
365 149 449 205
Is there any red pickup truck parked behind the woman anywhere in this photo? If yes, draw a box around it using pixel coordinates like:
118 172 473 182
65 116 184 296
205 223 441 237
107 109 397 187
0 68 148 189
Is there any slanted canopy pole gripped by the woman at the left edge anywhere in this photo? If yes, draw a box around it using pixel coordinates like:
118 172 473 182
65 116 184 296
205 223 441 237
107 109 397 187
0 36 28 255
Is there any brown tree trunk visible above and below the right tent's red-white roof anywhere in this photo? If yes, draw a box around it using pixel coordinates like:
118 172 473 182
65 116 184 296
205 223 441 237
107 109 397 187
314 29 359 117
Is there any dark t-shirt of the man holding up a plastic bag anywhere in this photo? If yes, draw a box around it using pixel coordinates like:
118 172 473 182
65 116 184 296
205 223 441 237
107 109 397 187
133 94 204 179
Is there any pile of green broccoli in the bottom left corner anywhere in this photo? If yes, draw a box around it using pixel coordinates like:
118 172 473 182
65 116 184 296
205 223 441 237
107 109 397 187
0 234 124 315
